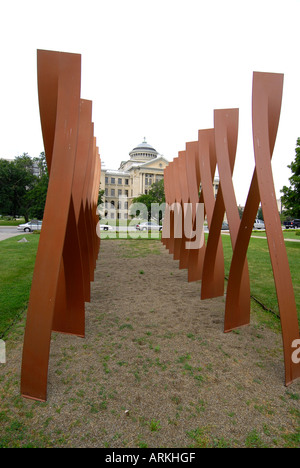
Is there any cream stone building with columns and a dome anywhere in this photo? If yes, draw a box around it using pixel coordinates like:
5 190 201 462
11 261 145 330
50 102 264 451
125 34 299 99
100 138 169 220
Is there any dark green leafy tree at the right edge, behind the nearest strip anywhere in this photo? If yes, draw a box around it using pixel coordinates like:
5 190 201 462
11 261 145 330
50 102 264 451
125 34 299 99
281 138 300 218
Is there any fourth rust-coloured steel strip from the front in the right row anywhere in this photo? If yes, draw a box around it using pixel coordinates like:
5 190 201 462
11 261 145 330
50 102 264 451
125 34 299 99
186 141 205 282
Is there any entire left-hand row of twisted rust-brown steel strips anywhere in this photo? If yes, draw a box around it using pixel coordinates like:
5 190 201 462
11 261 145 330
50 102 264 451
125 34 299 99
21 51 100 401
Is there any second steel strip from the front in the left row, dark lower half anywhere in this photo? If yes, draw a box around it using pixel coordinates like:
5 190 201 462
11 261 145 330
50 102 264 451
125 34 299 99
52 100 92 337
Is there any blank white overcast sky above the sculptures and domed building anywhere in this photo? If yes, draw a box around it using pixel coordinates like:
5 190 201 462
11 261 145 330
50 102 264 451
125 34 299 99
0 0 300 204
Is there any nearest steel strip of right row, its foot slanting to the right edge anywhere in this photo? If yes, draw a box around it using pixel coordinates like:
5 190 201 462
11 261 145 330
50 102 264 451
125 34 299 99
252 72 300 385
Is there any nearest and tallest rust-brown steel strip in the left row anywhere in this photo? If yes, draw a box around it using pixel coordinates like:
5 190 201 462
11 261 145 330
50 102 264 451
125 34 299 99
21 51 81 401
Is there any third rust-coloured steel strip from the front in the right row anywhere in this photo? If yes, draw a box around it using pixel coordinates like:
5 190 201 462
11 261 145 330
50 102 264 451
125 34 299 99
198 129 225 299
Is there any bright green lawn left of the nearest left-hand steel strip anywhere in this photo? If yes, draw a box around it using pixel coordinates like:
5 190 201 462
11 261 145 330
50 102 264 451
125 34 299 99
0 235 40 337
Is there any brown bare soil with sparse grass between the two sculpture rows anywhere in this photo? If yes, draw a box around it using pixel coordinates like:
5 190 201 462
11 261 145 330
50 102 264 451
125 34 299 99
0 240 300 448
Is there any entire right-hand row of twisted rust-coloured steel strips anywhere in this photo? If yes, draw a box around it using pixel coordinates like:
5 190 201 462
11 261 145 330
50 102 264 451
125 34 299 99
164 73 300 385
